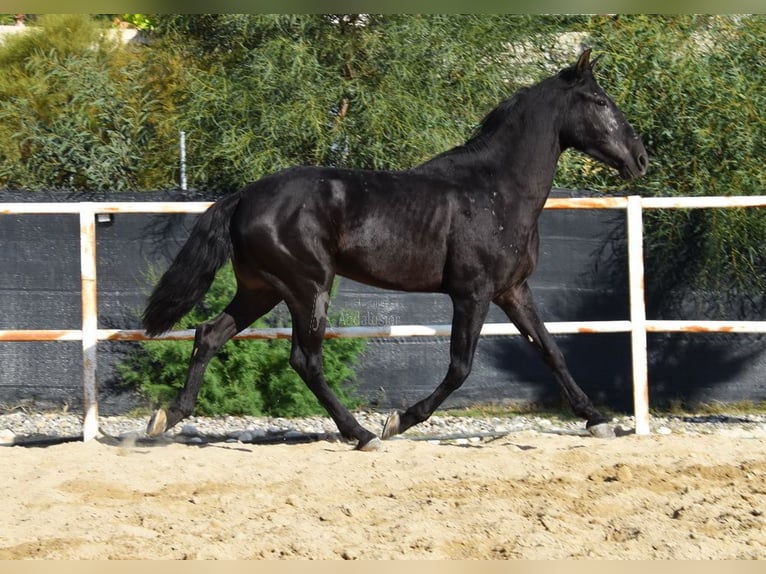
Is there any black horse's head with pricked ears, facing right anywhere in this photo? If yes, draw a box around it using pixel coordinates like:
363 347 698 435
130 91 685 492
558 48 649 179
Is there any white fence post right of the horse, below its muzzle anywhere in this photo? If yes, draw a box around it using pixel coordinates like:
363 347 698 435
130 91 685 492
627 195 650 435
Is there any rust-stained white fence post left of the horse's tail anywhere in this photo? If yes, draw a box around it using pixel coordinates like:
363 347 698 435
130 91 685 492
80 202 98 441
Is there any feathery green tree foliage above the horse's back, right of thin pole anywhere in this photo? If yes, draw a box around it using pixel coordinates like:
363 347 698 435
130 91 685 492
152 14 584 189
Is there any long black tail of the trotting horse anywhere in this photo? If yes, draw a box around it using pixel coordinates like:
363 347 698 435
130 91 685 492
143 192 240 336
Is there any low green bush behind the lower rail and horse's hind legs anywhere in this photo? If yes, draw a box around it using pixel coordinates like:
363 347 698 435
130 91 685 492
118 265 365 416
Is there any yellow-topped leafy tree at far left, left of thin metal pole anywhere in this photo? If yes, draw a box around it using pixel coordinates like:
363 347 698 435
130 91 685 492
0 14 180 191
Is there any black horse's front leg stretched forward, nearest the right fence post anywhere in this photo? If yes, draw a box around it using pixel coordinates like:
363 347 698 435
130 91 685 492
494 283 614 438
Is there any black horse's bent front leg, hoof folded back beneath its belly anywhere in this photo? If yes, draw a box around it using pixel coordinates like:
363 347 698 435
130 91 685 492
382 297 489 439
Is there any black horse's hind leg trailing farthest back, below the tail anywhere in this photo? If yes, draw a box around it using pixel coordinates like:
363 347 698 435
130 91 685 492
146 289 281 436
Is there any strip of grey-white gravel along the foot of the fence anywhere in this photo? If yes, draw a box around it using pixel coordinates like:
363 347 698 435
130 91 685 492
0 411 766 446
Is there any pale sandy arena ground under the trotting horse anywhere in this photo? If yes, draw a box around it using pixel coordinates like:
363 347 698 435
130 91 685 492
0 431 766 559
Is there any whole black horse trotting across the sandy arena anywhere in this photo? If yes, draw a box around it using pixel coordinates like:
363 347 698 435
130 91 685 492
143 49 648 450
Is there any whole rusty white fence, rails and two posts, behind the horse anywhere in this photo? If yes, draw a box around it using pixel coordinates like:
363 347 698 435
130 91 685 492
0 195 766 441
